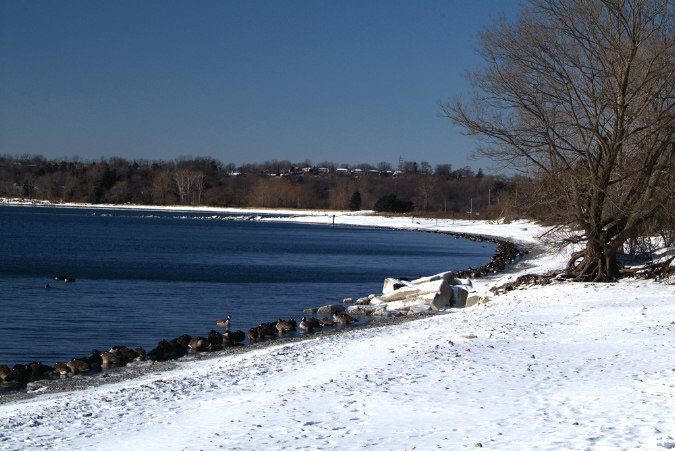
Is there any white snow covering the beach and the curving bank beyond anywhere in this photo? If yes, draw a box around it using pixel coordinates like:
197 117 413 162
0 212 675 450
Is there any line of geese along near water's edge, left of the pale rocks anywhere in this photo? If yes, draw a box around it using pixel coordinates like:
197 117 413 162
0 312 358 388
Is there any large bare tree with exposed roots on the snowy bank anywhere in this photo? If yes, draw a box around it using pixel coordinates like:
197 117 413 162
441 0 675 281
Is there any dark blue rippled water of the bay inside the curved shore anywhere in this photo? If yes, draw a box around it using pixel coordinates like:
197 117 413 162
0 206 496 367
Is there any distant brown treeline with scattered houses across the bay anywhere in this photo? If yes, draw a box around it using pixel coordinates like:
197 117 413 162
0 155 523 215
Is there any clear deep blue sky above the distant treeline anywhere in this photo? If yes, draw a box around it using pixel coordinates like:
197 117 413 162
0 0 518 170
